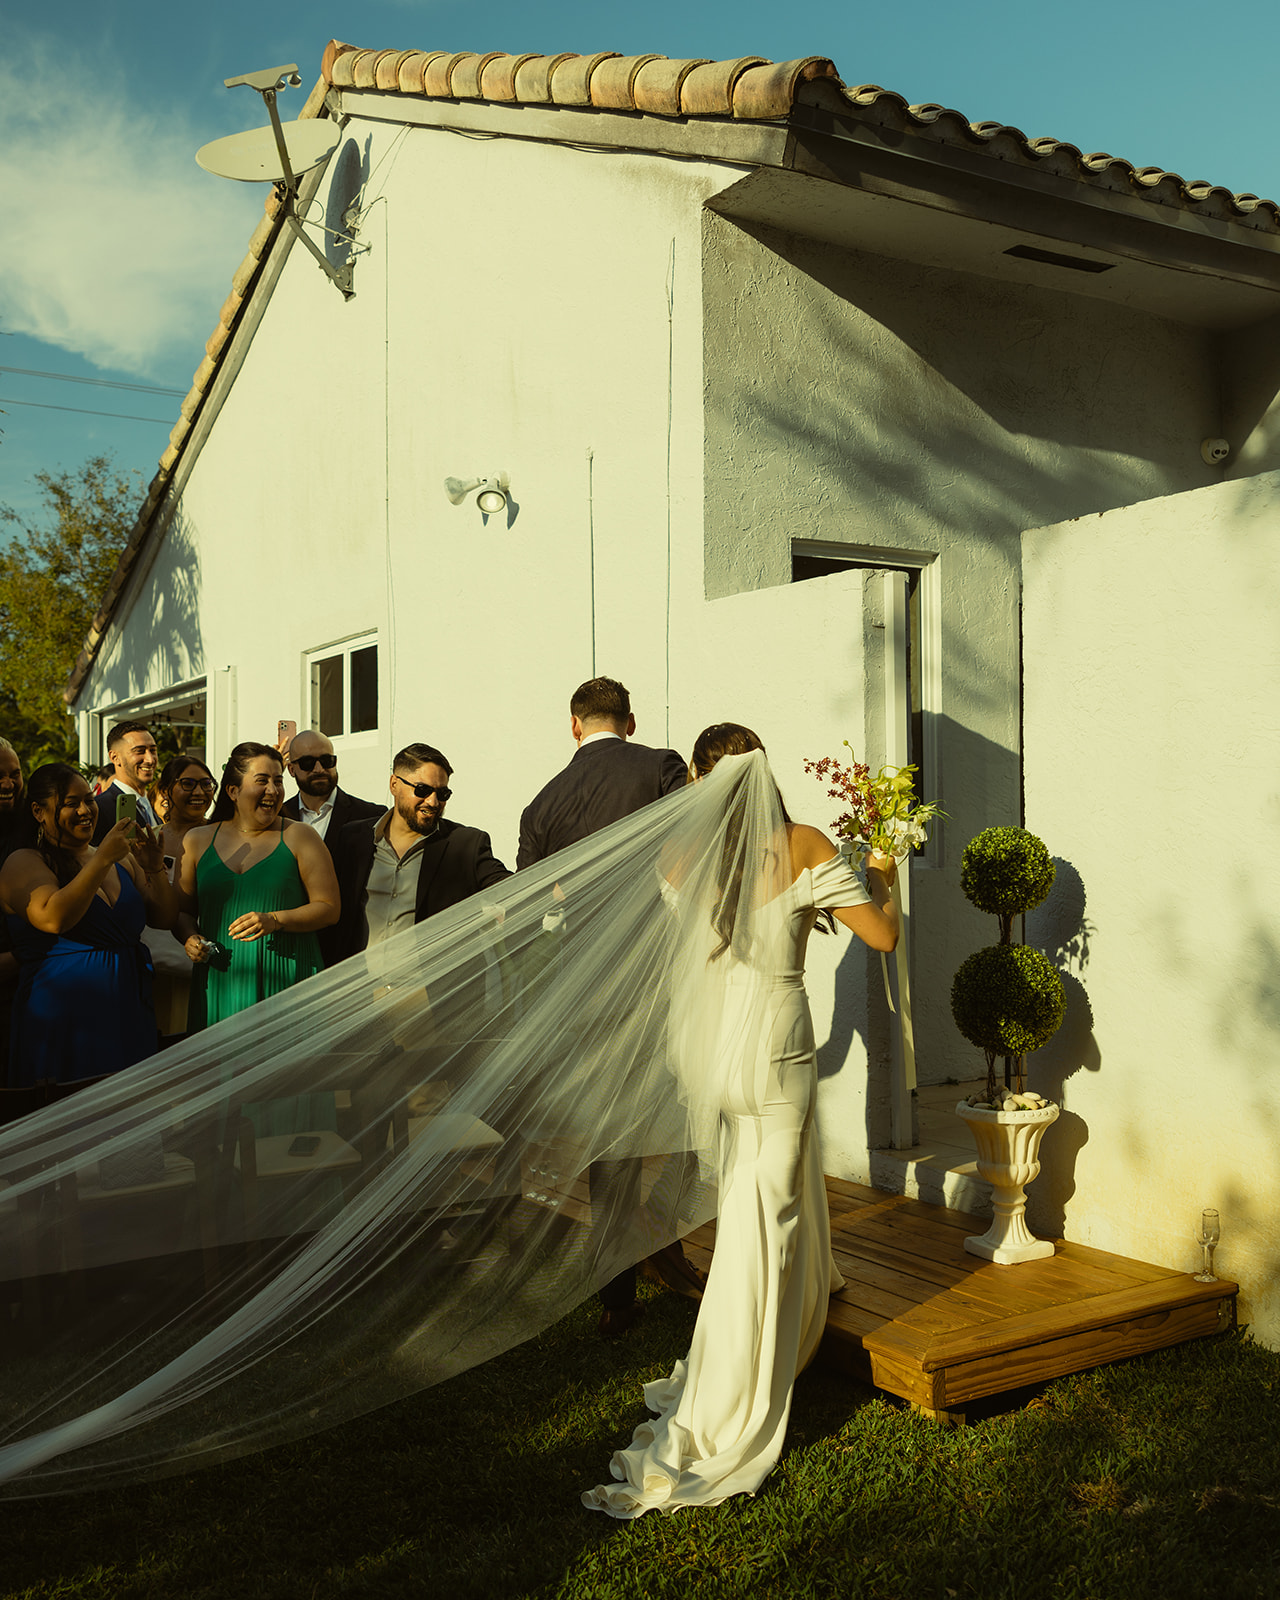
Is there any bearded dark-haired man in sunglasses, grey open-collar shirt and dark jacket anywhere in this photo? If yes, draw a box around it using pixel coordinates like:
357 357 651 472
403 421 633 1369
333 744 510 960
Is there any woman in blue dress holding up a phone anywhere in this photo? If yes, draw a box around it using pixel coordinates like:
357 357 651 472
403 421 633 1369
0 762 178 1085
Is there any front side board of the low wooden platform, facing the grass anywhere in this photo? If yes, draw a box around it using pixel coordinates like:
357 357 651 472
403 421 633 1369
941 1299 1219 1406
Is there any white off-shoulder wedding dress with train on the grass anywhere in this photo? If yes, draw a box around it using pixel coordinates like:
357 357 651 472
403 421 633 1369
582 856 869 1518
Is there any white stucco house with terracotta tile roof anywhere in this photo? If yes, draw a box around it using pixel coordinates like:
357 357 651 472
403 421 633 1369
67 42 1280 1344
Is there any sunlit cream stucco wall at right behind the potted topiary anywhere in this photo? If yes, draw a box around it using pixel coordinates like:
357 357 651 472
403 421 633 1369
1022 472 1280 1347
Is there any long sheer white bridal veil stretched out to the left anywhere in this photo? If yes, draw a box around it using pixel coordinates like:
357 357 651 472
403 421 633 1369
0 752 790 1496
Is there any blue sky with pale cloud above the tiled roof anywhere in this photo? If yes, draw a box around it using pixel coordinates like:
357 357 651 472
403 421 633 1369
0 0 1280 512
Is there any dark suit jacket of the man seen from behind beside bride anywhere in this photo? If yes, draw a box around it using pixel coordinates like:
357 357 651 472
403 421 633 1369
515 739 688 867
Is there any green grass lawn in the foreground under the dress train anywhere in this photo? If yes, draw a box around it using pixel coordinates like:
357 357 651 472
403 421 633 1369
0 1294 1280 1600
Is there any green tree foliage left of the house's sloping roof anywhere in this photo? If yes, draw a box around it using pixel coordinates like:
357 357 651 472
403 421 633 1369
0 456 142 768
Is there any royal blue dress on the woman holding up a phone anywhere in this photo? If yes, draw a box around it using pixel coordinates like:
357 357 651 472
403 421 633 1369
6 867 157 1088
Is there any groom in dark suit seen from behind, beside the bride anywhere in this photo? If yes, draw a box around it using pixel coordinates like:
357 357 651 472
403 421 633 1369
515 678 702 1339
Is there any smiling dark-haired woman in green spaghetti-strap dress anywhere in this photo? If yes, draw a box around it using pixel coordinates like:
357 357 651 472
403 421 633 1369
179 742 339 1136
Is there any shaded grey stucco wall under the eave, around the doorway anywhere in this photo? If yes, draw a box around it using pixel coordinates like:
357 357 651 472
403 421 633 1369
704 213 1221 1083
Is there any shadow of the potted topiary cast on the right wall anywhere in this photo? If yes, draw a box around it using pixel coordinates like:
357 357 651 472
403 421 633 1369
1024 856 1102 1238
